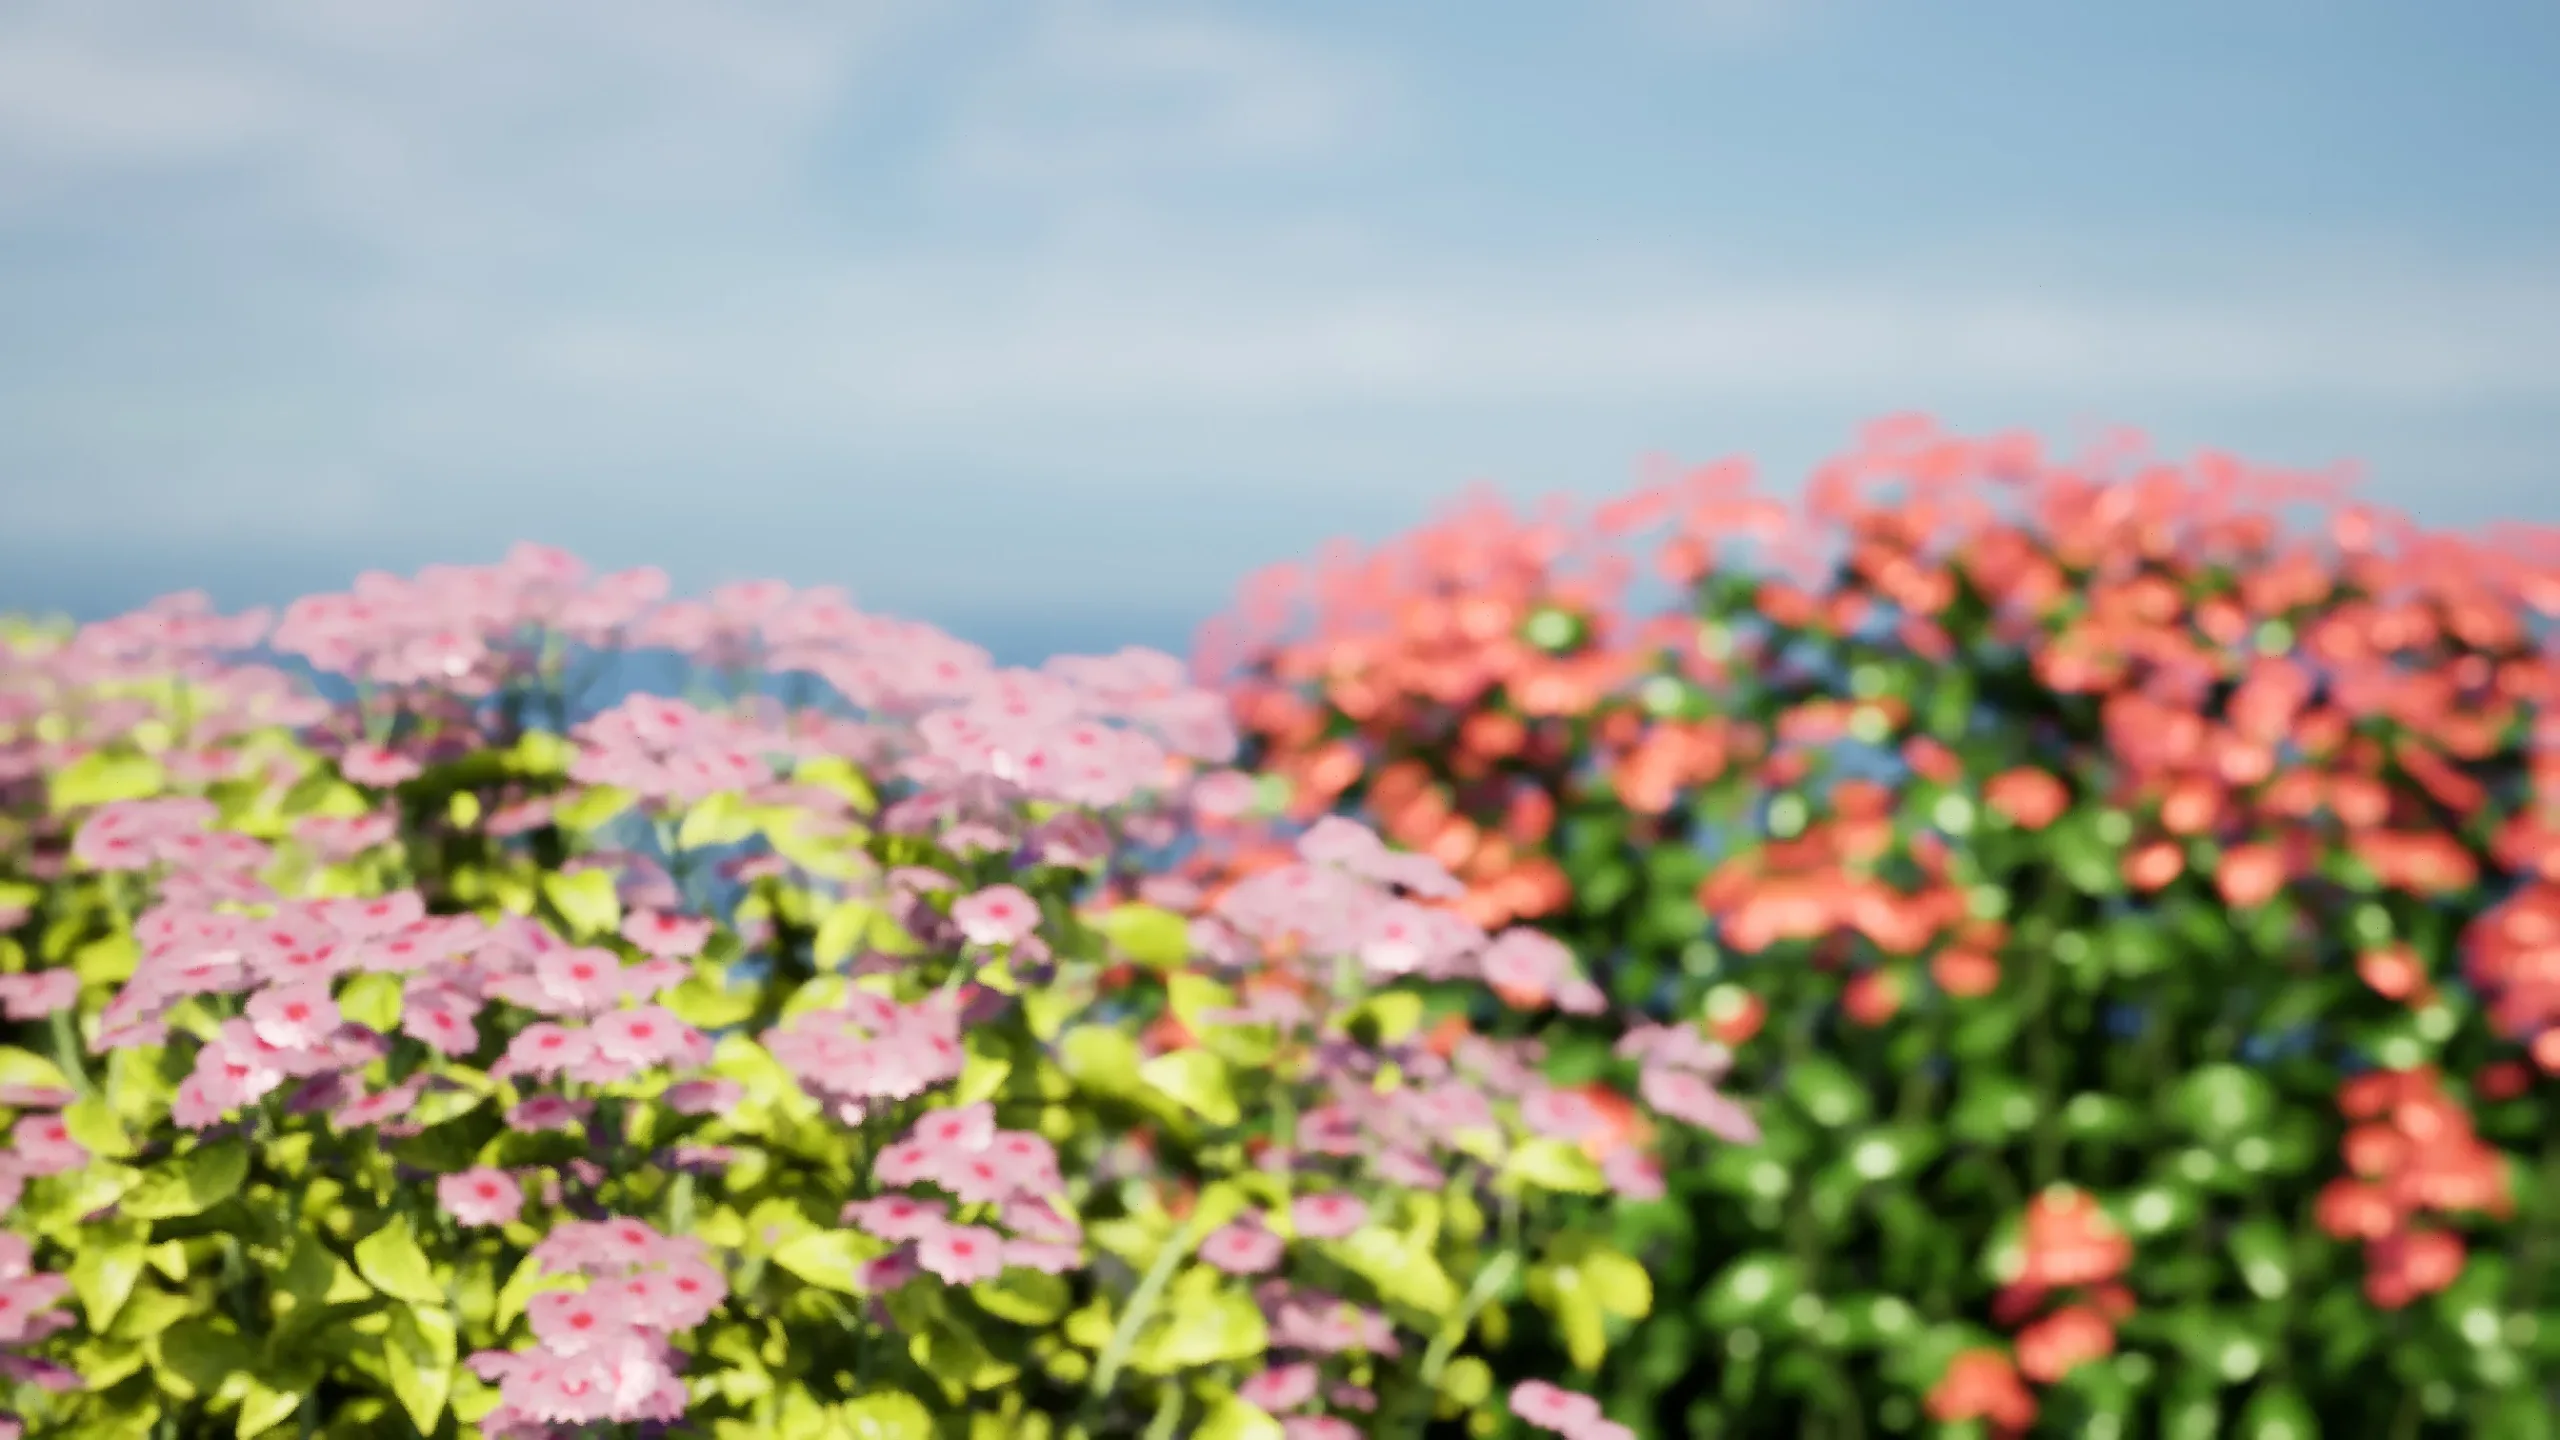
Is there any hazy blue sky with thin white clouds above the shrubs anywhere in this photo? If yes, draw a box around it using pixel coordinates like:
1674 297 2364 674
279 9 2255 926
0 0 2560 659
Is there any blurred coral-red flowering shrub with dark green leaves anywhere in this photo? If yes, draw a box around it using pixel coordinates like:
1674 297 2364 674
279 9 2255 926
1193 418 2560 1435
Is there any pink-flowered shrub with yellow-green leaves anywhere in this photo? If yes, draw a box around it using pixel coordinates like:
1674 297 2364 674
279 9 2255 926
0 548 1756 1440
